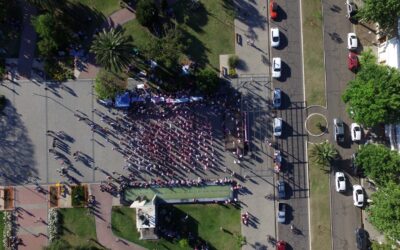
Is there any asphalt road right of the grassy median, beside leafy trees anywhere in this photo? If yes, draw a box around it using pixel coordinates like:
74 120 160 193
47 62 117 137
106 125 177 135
322 0 361 250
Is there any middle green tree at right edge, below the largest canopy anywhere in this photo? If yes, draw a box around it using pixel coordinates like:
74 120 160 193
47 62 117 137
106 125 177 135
356 144 400 185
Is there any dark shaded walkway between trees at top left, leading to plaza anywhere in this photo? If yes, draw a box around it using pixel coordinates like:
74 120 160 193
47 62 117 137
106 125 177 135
18 0 37 78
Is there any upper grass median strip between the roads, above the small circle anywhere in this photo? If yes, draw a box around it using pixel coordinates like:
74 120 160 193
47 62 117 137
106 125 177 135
302 0 326 106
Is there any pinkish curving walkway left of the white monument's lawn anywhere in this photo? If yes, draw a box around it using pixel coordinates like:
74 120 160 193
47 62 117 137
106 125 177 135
90 184 146 250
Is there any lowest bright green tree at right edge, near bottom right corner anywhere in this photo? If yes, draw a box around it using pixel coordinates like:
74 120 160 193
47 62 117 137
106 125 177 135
367 182 400 240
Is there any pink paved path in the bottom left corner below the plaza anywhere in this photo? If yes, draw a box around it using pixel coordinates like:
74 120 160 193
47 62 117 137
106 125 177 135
14 186 48 250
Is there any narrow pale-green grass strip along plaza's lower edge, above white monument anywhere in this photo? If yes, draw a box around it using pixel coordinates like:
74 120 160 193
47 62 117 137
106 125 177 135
125 185 232 201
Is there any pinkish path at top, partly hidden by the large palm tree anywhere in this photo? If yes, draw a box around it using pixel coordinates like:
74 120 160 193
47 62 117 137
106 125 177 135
78 8 136 79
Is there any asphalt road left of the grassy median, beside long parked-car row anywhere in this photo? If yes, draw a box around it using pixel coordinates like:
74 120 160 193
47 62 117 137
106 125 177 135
270 0 309 249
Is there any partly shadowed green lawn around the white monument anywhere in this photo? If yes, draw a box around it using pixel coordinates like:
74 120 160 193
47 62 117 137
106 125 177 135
111 204 241 250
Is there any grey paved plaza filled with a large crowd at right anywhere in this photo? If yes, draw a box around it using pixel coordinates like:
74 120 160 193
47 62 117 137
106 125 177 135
1 81 253 185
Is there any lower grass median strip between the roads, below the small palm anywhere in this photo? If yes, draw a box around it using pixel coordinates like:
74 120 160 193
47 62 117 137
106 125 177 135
308 144 332 249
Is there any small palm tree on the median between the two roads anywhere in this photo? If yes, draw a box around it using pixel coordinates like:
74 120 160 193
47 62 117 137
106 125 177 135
310 141 338 167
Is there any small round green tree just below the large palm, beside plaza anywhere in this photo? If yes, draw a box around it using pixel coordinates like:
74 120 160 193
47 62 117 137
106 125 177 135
94 69 127 99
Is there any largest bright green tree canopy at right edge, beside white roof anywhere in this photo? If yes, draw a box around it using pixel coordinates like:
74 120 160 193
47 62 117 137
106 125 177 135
342 51 400 127
